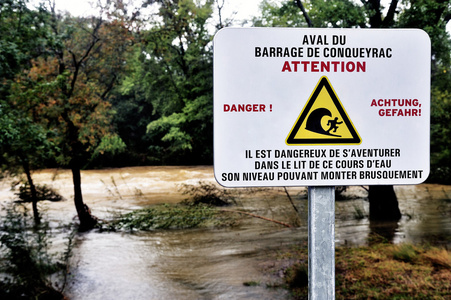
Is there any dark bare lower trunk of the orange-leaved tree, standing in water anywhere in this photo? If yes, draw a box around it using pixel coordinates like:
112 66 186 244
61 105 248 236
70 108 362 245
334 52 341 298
71 164 97 231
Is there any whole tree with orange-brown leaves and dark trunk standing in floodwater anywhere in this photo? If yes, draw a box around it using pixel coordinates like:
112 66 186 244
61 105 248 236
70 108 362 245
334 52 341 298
8 1 132 230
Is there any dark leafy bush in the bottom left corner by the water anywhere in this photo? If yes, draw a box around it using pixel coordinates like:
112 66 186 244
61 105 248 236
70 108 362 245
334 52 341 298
0 205 72 299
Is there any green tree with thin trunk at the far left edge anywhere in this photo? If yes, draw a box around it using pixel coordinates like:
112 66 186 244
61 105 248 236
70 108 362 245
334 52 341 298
0 0 54 225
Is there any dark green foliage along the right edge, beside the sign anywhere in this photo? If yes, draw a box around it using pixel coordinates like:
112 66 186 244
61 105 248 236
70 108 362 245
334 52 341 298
398 0 451 184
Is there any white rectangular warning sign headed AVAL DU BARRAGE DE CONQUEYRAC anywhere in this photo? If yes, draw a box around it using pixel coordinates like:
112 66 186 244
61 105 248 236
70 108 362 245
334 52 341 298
214 28 431 187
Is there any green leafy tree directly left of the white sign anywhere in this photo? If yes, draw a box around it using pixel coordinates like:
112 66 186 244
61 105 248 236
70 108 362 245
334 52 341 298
115 0 213 164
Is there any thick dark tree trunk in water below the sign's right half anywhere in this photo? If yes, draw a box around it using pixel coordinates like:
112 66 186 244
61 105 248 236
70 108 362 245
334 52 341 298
368 185 401 221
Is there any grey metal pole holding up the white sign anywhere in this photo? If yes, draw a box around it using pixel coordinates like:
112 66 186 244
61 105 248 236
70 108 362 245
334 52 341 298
308 186 335 300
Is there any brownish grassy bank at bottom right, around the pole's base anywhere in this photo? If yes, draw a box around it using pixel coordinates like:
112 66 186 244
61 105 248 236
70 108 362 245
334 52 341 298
276 243 451 299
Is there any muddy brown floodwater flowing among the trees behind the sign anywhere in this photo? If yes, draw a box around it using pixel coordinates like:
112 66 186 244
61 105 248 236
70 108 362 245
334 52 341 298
0 166 451 300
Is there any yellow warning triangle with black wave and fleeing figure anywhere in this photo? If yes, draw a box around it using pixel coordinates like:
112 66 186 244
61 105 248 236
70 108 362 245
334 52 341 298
286 76 362 145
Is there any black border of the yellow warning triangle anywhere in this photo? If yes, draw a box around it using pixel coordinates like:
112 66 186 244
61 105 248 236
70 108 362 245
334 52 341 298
286 76 362 146
